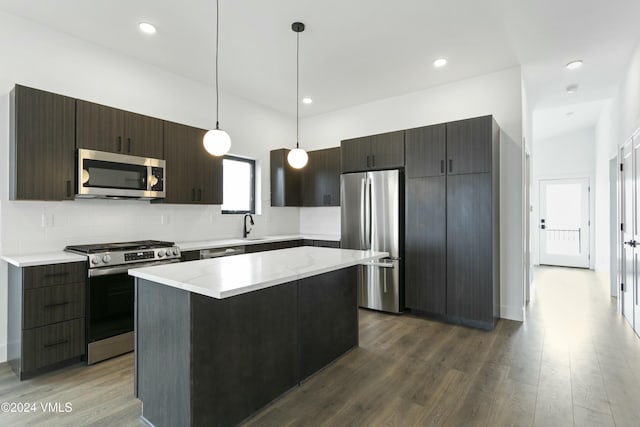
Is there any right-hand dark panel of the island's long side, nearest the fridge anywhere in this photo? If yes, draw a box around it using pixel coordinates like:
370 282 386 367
298 267 358 380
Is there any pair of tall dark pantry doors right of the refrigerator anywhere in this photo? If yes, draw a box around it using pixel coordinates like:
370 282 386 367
405 173 500 329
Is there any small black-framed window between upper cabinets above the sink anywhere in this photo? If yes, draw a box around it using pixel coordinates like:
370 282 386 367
222 156 256 214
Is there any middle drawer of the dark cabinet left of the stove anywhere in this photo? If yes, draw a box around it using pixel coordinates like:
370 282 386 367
22 283 86 329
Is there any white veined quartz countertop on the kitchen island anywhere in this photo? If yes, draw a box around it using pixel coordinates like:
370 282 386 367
129 246 388 299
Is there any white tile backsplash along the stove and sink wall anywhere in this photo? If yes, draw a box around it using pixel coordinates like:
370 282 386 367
1 200 300 254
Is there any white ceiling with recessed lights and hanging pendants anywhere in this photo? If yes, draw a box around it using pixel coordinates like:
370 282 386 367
0 0 640 134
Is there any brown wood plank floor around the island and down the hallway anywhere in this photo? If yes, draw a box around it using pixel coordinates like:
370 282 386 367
0 267 640 426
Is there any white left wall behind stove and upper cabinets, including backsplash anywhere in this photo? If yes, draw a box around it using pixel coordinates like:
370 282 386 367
0 13 299 361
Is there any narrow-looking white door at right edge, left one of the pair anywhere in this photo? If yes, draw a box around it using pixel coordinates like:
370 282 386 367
620 141 637 332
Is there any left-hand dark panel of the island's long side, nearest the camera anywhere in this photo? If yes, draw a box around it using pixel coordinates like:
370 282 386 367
191 282 299 426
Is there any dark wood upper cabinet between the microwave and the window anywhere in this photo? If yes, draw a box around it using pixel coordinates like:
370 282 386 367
163 121 223 205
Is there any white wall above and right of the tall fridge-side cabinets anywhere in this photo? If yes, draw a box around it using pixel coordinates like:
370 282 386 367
300 68 523 320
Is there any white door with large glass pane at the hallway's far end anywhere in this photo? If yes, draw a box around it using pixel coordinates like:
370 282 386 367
539 178 590 268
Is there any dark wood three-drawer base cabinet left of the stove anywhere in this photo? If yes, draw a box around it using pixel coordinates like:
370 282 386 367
7 262 87 380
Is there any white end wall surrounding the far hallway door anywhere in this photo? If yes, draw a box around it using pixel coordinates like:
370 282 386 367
531 128 595 268
